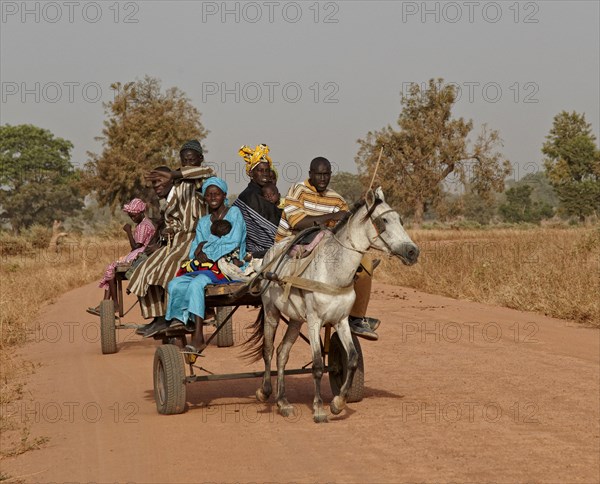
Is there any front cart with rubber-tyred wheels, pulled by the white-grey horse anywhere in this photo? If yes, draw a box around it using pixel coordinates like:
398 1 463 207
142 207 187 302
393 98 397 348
153 282 364 415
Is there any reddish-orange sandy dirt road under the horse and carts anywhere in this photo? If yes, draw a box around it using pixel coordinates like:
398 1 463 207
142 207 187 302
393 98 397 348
1 284 600 482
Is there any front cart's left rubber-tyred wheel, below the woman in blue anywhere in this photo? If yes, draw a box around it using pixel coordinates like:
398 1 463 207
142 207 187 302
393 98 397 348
154 345 185 415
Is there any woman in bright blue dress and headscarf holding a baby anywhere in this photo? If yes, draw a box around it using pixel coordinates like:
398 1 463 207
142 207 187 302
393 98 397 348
166 177 246 351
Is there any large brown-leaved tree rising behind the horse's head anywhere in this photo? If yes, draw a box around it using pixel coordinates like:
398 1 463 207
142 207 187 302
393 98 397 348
356 79 510 225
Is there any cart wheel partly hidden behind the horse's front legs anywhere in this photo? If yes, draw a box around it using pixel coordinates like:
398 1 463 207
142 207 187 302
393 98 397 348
327 333 365 402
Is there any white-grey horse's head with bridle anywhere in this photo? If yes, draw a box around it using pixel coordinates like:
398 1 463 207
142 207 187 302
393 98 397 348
363 187 419 266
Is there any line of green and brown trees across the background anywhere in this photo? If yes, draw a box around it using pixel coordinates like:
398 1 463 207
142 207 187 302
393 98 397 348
0 76 600 233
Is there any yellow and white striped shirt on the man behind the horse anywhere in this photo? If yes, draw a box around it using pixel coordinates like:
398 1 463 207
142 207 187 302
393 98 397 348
275 180 348 242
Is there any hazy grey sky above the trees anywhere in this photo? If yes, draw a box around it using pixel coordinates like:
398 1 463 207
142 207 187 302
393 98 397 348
0 0 600 192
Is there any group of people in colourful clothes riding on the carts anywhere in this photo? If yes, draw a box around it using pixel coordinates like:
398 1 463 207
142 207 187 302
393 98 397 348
88 140 379 350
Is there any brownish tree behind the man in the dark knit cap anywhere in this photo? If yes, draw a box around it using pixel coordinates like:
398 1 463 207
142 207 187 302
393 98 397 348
83 76 208 210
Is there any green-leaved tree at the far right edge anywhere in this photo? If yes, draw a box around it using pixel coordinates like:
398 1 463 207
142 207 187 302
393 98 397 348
542 111 600 221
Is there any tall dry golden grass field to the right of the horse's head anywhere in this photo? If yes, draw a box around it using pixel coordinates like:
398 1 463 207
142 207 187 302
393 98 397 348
376 227 600 325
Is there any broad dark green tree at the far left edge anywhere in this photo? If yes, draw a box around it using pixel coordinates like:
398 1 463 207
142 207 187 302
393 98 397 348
0 124 83 233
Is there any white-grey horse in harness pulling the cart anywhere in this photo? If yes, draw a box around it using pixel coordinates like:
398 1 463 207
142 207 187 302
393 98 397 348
247 187 419 423
